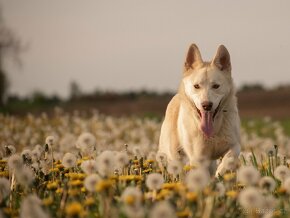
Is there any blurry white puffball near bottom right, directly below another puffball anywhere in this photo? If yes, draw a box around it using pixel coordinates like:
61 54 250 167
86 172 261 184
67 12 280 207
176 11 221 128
238 186 263 209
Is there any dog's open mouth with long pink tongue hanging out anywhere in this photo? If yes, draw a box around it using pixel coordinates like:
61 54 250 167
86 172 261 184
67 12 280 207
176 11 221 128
195 101 221 137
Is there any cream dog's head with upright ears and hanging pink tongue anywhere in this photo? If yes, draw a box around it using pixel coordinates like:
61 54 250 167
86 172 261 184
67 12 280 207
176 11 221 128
182 44 232 137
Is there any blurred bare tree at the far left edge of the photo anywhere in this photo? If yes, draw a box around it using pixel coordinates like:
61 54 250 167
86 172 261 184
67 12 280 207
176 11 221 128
0 8 23 107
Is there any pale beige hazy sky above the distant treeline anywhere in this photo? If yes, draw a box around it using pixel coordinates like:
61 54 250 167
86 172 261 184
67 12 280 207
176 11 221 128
0 0 290 97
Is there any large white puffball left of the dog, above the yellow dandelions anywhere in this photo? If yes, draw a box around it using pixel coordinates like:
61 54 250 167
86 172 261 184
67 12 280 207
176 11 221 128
97 151 115 176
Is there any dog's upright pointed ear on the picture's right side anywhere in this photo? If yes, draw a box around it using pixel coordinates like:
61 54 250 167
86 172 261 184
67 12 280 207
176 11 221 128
211 45 232 72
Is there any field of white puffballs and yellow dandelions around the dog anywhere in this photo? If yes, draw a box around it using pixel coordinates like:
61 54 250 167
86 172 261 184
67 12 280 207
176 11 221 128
0 110 290 218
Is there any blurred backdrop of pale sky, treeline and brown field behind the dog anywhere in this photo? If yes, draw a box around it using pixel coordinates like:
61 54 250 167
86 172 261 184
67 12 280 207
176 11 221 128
0 0 290 119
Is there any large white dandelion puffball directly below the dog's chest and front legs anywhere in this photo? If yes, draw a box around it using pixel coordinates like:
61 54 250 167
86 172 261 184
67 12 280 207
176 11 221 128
185 168 210 191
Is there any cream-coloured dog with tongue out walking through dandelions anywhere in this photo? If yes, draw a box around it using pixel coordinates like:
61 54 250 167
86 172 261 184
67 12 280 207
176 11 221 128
159 44 240 176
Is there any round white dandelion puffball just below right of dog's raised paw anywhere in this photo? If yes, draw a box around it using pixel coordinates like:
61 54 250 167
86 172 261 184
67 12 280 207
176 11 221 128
237 166 260 185
